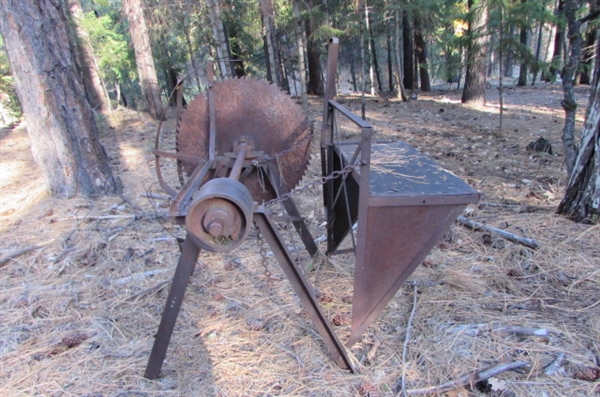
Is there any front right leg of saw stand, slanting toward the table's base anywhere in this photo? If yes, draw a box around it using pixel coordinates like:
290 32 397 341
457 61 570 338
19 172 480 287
254 207 353 371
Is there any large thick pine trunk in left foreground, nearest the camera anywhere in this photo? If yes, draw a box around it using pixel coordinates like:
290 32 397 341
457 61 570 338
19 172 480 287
0 0 120 197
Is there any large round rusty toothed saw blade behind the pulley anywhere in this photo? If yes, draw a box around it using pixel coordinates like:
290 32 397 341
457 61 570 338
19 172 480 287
177 79 311 202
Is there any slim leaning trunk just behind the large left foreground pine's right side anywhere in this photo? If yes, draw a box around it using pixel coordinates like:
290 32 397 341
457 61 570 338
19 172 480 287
68 0 111 112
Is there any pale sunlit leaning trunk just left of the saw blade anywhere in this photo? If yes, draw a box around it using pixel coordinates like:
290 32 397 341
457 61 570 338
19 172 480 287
123 0 163 119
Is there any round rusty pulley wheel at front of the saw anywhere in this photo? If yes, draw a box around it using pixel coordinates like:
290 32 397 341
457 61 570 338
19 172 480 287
185 178 253 252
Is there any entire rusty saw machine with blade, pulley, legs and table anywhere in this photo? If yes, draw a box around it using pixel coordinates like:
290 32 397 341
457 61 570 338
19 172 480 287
145 38 479 379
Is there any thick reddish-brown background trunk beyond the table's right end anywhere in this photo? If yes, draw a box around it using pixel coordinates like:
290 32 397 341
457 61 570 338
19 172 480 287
461 0 487 105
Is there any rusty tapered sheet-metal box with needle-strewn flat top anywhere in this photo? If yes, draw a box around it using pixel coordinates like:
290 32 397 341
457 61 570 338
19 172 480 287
339 142 479 346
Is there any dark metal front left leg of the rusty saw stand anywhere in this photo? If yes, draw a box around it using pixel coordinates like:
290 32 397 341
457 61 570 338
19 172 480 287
144 234 200 379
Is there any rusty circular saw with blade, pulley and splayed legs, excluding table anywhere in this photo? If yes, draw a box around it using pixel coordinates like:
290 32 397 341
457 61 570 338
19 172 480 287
145 66 322 379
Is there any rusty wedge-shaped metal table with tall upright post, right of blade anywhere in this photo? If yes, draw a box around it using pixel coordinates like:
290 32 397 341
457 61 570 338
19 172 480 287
321 38 479 346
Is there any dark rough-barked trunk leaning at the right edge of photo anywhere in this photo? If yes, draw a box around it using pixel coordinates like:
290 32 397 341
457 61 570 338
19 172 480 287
557 44 600 222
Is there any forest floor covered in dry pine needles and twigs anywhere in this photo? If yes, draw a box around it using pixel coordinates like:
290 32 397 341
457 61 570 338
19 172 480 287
0 84 600 397
